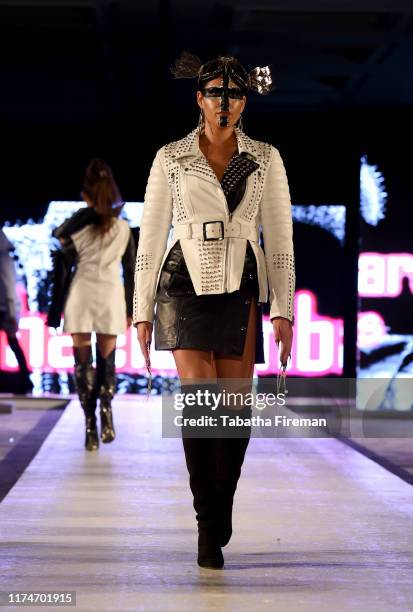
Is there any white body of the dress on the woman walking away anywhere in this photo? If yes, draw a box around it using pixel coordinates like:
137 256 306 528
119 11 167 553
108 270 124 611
63 218 130 335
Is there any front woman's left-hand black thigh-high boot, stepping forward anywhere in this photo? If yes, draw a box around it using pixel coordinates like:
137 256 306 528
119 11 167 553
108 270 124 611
181 385 224 569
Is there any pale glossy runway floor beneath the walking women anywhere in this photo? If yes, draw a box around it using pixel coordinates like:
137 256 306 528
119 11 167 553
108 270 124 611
0 398 413 612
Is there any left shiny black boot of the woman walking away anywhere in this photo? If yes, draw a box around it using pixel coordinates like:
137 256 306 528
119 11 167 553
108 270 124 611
73 347 99 451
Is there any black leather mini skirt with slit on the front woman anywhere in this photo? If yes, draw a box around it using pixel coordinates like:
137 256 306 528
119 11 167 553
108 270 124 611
154 240 265 363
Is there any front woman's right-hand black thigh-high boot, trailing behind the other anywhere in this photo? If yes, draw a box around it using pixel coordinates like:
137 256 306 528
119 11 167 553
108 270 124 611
215 407 251 546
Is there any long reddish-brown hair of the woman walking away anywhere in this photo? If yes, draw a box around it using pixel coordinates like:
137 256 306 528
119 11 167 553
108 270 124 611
82 158 123 235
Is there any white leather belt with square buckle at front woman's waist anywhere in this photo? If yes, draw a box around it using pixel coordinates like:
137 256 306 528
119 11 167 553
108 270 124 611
171 219 259 242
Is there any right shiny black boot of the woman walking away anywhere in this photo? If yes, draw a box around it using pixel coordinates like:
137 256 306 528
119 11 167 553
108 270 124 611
96 348 116 444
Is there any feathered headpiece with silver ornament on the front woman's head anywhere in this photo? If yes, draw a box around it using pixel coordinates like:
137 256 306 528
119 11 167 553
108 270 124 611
171 51 275 95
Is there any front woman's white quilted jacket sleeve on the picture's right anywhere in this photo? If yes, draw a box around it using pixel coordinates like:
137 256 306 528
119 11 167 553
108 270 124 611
259 147 295 323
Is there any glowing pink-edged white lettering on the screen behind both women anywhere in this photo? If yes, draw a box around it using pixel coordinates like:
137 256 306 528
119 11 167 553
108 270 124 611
0 291 343 376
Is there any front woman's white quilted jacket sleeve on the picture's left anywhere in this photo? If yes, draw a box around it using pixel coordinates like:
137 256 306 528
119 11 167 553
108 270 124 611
133 147 172 325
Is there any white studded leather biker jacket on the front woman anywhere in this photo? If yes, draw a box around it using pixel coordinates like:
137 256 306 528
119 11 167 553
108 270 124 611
133 128 295 325
